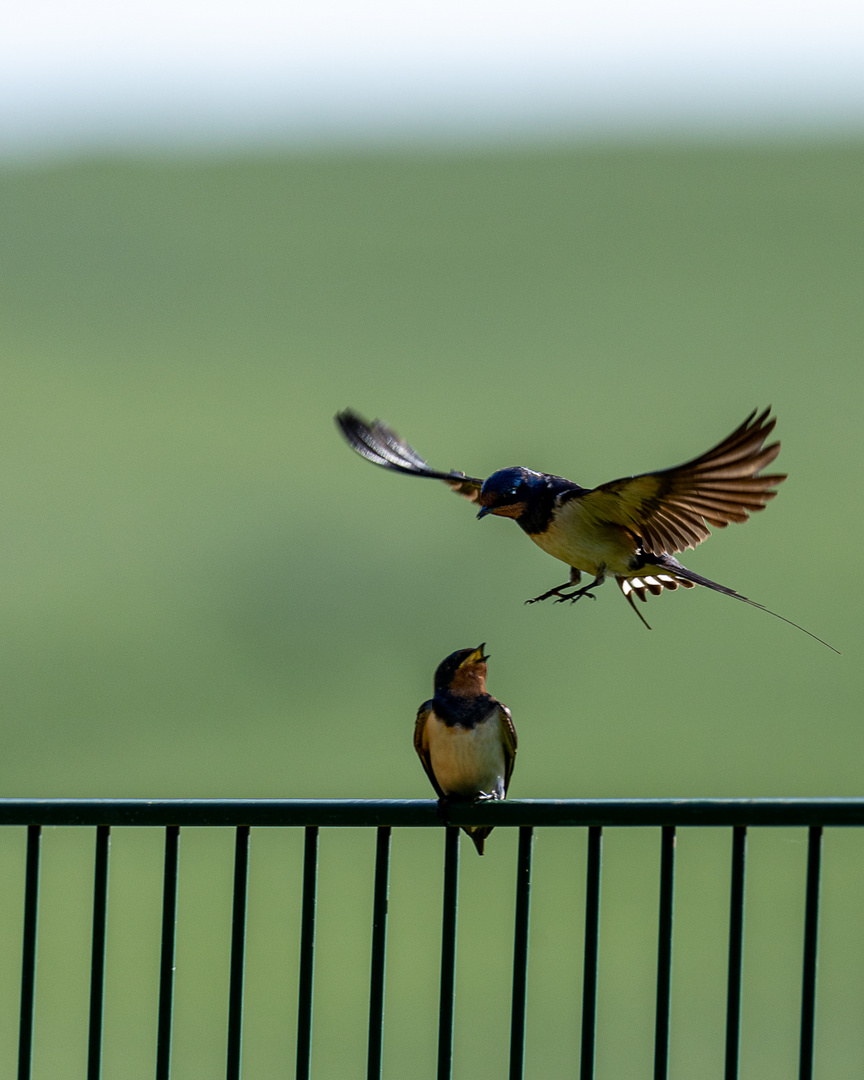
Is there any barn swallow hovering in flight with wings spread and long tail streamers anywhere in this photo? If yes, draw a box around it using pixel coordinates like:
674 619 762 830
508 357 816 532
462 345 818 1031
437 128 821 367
335 406 837 652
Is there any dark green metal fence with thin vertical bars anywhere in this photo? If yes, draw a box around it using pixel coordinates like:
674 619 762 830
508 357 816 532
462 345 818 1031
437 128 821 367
0 799 864 1080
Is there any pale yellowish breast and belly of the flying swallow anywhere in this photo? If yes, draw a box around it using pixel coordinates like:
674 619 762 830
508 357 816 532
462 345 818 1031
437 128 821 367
528 499 637 577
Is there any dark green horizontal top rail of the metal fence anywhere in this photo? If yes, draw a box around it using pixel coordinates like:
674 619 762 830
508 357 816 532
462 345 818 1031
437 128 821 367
0 798 864 828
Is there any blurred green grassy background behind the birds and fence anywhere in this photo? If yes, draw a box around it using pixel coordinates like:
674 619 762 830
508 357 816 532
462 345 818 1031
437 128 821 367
0 141 864 1080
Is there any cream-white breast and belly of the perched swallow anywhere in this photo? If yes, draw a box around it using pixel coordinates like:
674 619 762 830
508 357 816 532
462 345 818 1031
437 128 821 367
426 708 507 799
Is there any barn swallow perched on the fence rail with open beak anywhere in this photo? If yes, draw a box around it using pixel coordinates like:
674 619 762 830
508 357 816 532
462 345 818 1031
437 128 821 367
414 643 516 855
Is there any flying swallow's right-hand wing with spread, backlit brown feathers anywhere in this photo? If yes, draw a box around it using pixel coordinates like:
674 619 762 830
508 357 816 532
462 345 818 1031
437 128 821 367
564 406 786 553
